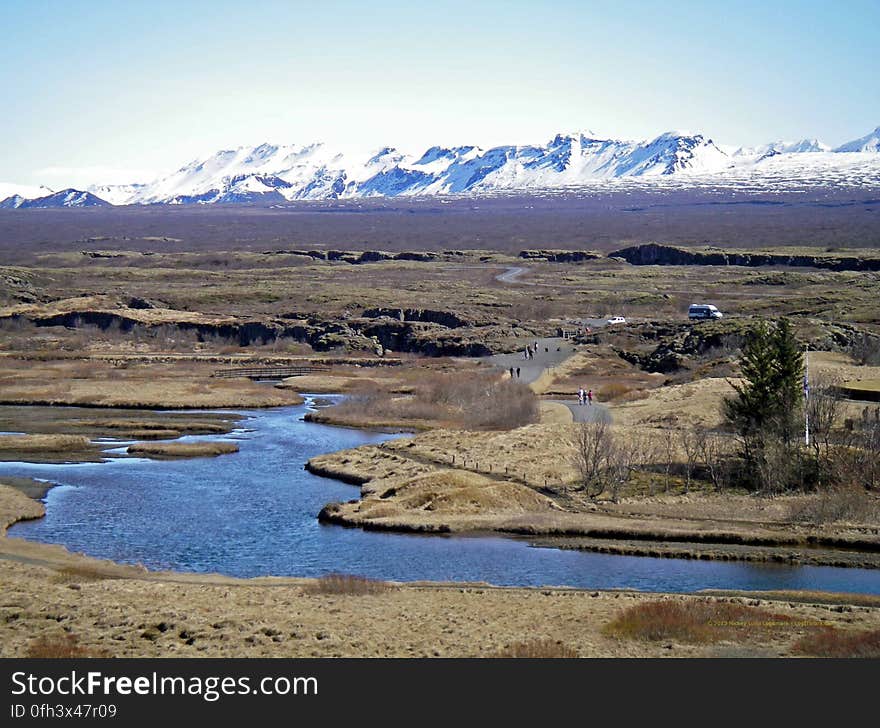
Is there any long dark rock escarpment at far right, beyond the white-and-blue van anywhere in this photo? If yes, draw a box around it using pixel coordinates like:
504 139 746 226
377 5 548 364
608 243 880 271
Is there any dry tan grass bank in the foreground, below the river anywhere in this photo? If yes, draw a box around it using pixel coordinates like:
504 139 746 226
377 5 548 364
0 485 880 657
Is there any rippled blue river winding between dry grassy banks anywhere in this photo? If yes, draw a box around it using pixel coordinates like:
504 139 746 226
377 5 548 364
0 402 880 594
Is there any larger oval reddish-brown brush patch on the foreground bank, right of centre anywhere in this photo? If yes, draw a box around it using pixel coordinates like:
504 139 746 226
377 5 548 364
602 600 794 644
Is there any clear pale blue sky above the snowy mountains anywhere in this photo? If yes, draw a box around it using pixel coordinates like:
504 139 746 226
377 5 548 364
0 0 880 187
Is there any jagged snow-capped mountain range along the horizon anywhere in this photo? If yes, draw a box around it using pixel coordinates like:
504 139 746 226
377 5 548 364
0 127 880 208
